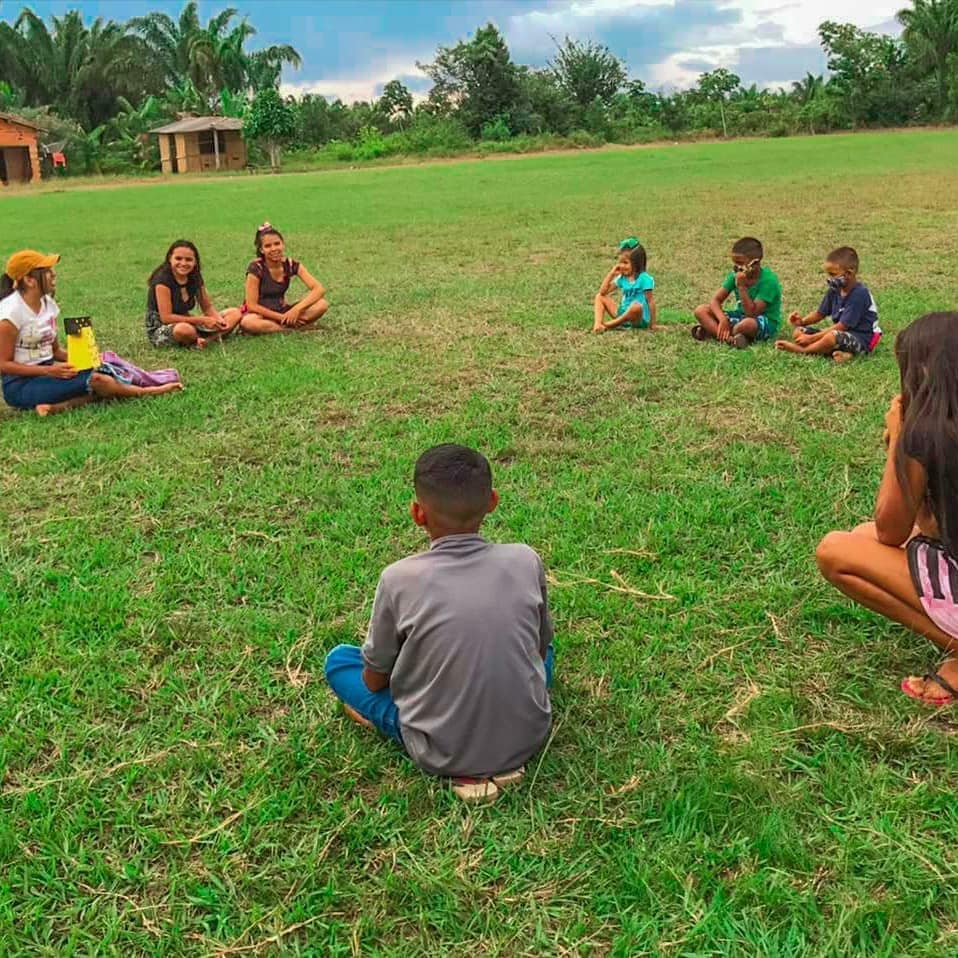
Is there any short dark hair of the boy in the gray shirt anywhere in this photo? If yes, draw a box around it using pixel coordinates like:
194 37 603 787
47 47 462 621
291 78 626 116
413 443 492 523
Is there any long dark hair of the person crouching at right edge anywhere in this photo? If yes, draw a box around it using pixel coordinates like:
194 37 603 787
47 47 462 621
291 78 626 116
895 313 958 558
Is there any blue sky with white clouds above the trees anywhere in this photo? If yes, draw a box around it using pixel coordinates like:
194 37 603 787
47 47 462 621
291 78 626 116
7 0 903 101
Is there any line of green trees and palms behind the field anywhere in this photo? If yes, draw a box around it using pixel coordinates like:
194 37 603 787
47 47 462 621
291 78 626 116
0 0 958 172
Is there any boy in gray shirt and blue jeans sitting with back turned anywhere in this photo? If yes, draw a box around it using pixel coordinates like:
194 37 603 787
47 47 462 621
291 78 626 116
325 444 553 801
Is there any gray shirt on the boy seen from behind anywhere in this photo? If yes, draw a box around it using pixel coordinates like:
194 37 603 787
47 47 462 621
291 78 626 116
363 535 552 776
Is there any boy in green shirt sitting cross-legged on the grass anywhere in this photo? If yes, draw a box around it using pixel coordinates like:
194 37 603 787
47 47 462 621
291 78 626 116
692 236 782 349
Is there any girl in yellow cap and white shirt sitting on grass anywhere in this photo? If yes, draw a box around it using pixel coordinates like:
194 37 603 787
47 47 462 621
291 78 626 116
0 250 182 416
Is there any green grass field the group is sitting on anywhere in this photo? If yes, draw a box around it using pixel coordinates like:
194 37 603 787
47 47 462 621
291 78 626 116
0 132 958 958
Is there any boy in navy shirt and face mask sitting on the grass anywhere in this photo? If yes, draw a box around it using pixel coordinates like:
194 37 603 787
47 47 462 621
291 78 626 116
775 246 881 363
